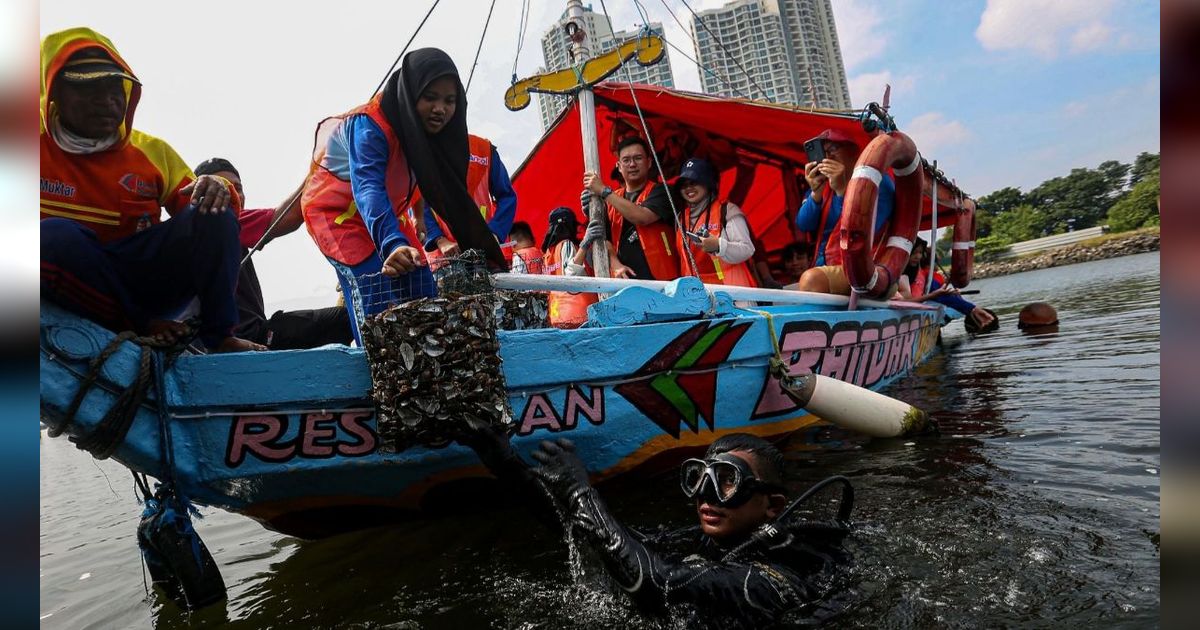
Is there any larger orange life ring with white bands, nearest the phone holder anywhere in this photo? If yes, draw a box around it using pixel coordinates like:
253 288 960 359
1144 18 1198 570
839 131 925 298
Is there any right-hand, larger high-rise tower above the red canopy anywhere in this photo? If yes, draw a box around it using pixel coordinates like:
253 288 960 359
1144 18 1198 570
691 0 851 109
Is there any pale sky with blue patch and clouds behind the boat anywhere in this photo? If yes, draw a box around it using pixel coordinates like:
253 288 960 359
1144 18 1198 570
35 0 1159 313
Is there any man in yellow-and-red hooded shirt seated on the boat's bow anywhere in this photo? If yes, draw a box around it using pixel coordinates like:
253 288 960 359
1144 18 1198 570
40 28 264 352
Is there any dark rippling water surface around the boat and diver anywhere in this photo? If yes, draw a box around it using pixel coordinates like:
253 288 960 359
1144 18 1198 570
41 253 1159 628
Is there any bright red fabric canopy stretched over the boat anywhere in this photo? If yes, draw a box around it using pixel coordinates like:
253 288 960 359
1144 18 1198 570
512 82 958 251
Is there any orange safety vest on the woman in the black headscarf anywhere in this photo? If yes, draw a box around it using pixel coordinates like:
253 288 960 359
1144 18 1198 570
300 92 419 266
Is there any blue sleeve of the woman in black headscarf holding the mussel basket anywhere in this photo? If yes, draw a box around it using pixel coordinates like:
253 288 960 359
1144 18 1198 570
346 115 412 260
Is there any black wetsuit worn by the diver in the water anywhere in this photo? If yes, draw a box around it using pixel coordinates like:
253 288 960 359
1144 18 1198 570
463 434 848 629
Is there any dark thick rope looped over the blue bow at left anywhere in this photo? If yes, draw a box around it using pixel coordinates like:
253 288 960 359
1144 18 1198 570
47 325 197 460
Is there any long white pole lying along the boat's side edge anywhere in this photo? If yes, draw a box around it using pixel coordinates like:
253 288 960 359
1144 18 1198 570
492 274 937 311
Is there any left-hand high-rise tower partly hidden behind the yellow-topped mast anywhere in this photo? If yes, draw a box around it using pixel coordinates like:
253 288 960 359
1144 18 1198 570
538 5 674 130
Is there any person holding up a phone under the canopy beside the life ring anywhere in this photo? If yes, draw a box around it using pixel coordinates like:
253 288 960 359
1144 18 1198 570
796 128 896 295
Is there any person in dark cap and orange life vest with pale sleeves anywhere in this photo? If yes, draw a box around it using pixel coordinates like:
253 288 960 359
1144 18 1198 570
676 157 757 287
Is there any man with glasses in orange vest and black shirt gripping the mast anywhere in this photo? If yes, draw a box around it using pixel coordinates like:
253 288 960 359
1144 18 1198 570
568 136 679 280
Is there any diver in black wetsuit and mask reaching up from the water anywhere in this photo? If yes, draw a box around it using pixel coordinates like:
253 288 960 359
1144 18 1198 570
463 432 853 628
